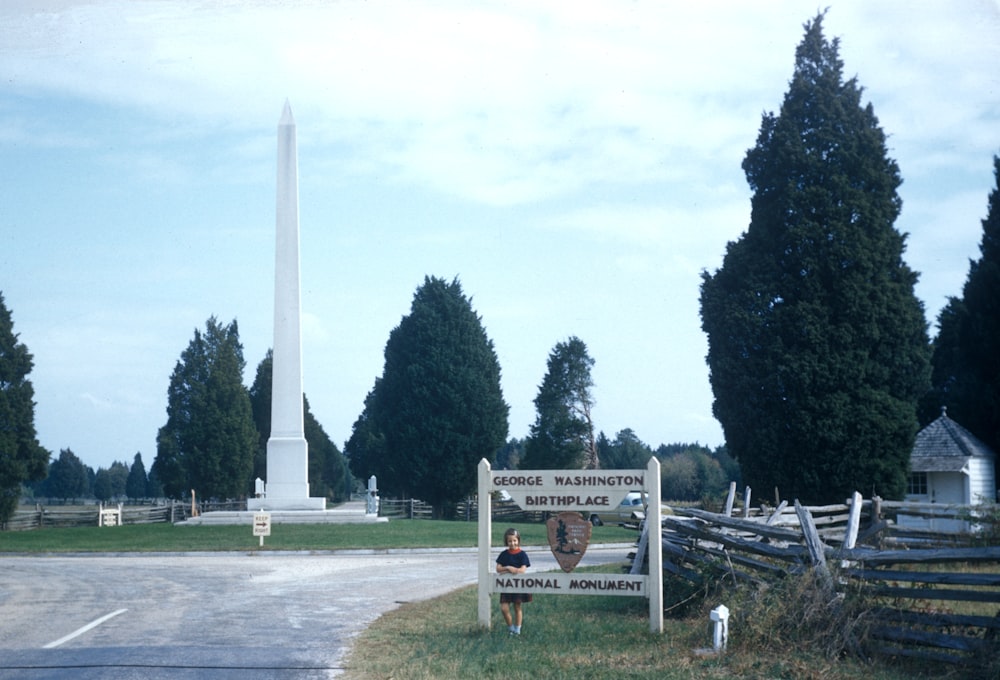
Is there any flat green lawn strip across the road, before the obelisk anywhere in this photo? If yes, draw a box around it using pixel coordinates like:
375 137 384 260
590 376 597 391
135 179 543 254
0 519 636 554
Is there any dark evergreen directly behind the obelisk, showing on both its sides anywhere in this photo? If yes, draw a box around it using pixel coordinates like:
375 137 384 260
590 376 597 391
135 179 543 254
250 350 347 501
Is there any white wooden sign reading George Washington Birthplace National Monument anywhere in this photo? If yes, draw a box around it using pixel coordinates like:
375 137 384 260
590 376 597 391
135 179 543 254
478 457 663 633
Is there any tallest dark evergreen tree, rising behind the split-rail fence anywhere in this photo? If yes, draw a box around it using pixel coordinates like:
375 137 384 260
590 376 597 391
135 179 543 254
701 14 929 502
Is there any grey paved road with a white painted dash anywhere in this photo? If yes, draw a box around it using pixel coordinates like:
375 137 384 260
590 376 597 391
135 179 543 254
0 546 628 680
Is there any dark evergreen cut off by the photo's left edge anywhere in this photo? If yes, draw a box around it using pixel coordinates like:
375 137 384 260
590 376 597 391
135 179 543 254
0 293 49 524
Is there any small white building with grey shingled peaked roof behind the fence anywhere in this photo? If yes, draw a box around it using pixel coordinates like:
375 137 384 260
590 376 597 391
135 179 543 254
899 409 997 531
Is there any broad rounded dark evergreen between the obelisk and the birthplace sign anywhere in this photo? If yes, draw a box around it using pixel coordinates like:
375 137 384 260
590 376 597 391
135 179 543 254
347 277 509 514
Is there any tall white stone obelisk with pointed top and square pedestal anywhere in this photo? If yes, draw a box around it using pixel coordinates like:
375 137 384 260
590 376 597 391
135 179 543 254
258 101 326 510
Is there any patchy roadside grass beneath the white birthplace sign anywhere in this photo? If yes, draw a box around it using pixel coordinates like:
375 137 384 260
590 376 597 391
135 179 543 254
345 567 920 680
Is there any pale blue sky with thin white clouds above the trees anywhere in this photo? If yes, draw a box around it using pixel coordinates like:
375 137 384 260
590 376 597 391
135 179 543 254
0 0 1000 469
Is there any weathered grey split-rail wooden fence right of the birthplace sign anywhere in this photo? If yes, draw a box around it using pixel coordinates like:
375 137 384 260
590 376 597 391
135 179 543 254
631 489 1000 665
